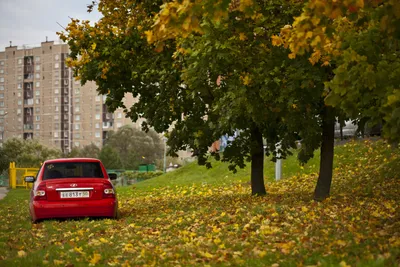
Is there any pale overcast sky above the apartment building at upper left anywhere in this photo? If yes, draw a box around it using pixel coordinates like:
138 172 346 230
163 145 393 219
0 0 100 51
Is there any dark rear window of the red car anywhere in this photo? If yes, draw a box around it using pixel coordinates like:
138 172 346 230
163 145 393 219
43 162 104 180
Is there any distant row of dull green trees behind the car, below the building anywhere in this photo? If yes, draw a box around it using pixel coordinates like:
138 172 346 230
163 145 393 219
0 126 164 174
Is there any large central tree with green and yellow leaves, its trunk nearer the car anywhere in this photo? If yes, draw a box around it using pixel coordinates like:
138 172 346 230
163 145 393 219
61 0 335 197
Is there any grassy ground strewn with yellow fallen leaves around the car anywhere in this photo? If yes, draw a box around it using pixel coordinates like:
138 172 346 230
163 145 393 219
0 142 400 266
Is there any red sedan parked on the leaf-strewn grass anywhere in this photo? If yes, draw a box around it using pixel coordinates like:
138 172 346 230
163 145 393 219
25 158 118 222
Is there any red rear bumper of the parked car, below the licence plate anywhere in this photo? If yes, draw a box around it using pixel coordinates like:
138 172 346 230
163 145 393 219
30 199 118 220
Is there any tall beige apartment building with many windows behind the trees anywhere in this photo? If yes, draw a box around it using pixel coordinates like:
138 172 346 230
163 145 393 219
0 41 139 152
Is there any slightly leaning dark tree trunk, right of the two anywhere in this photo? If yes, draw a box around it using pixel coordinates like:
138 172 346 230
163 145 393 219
314 106 335 201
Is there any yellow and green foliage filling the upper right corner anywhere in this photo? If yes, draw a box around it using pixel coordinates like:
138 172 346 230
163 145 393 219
276 0 400 142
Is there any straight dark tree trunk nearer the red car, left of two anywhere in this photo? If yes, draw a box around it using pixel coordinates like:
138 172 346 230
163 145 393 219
250 127 267 196
